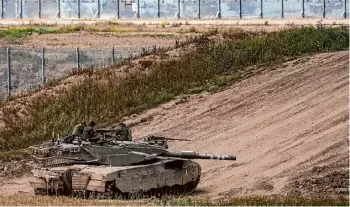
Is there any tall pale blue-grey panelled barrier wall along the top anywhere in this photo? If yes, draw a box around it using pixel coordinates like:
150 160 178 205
0 0 350 19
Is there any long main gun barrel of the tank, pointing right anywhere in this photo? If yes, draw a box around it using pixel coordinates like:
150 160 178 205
160 151 236 160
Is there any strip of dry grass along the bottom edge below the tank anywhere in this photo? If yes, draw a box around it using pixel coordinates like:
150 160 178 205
0 194 349 206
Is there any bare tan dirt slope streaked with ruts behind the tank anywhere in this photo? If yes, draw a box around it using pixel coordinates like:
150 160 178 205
0 51 349 198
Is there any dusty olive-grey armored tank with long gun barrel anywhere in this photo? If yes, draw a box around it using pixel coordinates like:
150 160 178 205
30 136 236 199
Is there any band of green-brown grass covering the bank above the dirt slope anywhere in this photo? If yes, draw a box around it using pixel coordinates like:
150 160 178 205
0 27 349 159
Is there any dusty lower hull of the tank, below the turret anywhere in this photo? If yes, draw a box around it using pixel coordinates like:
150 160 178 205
31 158 201 199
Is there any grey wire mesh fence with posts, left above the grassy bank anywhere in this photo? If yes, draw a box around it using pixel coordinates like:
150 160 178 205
0 46 155 100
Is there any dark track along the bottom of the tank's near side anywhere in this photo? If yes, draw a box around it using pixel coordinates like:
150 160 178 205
34 178 200 200
